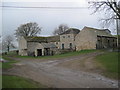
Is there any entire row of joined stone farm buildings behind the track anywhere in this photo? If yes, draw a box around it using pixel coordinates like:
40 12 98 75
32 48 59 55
19 27 117 56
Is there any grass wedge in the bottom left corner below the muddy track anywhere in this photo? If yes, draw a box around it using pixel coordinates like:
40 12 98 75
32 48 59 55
2 75 45 88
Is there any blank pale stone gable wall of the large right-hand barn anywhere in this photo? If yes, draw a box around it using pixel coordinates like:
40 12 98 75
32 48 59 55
75 30 97 51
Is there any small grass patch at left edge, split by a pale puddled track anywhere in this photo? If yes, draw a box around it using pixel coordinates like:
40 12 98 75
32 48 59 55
0 56 17 69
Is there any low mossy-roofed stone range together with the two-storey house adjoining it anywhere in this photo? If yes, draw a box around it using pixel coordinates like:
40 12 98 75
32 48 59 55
19 28 80 56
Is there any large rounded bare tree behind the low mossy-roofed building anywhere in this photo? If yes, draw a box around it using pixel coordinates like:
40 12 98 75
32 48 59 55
15 22 41 37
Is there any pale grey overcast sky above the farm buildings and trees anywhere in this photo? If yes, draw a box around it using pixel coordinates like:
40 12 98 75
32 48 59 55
0 0 117 39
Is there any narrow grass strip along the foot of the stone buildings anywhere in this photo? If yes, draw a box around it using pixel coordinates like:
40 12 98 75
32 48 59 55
16 50 97 59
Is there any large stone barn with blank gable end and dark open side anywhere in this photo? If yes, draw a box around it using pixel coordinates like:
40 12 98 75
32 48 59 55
75 27 117 51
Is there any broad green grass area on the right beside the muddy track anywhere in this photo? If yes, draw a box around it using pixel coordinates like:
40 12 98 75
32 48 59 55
96 52 118 79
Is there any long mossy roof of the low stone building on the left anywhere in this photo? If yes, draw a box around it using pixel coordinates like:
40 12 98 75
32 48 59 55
24 35 60 42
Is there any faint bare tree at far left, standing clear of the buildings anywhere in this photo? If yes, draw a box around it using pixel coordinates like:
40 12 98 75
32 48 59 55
2 35 15 52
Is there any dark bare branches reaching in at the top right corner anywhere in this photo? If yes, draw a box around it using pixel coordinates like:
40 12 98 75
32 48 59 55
89 0 120 26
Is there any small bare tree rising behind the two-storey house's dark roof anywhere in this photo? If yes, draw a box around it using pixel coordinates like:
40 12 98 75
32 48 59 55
53 24 69 35
